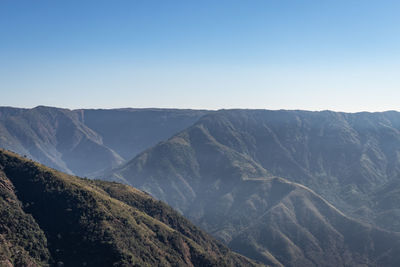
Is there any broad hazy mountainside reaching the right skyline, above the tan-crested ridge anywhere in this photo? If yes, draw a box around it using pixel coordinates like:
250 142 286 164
112 110 400 222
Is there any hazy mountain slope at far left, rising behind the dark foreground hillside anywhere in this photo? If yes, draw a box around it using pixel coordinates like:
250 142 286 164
0 107 123 178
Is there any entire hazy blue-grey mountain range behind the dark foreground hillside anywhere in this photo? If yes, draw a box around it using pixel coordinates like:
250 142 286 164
0 107 400 266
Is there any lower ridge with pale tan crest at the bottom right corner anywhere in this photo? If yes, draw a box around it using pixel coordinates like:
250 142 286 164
227 179 400 267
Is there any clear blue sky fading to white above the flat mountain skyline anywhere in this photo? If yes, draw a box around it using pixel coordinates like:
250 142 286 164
0 0 400 112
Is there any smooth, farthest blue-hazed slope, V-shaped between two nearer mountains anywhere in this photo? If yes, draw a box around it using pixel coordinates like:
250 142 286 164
82 108 209 160
